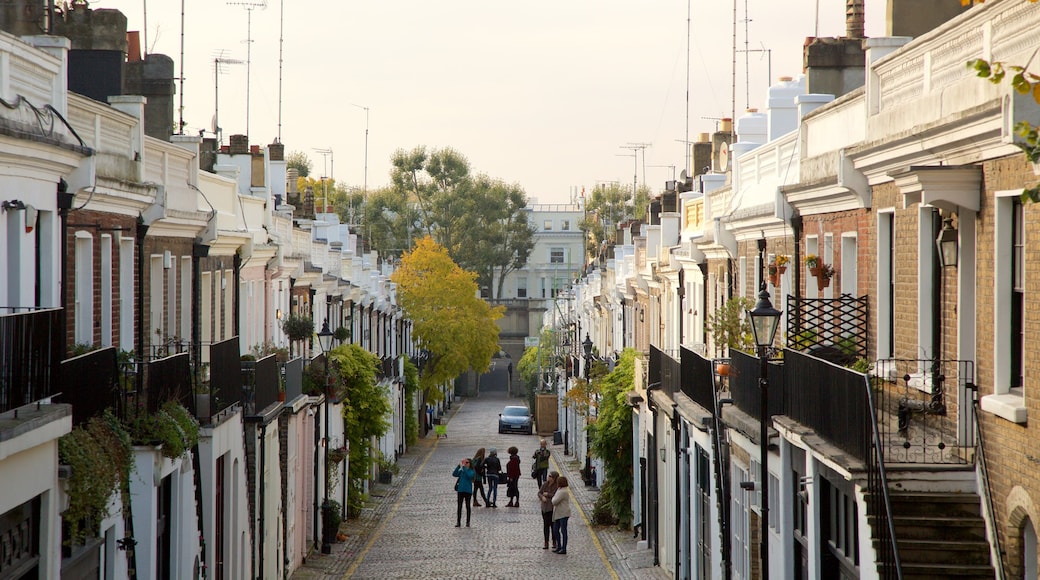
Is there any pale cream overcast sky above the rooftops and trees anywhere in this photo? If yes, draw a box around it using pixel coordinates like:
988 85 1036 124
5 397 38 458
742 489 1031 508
90 0 885 203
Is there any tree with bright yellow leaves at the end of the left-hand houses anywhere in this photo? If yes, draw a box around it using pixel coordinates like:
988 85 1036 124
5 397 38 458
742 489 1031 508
391 236 504 397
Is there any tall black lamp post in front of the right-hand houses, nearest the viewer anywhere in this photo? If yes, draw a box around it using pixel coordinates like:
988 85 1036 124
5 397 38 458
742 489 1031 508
748 278 780 579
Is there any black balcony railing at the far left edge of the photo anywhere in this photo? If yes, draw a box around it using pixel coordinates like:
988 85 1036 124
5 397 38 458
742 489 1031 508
0 309 64 413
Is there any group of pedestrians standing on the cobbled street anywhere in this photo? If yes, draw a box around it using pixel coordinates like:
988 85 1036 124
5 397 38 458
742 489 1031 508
451 439 571 554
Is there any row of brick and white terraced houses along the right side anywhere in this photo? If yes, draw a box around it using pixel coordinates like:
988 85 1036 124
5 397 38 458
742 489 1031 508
550 0 1040 578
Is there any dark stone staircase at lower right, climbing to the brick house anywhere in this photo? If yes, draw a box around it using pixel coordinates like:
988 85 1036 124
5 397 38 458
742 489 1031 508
869 492 995 580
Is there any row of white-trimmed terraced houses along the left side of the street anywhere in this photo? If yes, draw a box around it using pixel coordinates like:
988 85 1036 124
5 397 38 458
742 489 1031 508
0 3 425 578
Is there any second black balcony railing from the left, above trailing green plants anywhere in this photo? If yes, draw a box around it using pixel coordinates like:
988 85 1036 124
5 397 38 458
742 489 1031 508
57 347 124 426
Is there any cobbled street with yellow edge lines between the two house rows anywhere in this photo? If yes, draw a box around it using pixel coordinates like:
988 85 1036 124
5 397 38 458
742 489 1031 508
291 392 671 580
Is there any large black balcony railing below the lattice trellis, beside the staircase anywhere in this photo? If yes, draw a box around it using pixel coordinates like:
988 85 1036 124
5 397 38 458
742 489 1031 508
782 349 872 463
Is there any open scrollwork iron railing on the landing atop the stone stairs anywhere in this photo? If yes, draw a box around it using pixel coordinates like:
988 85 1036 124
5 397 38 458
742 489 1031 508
872 359 976 464
